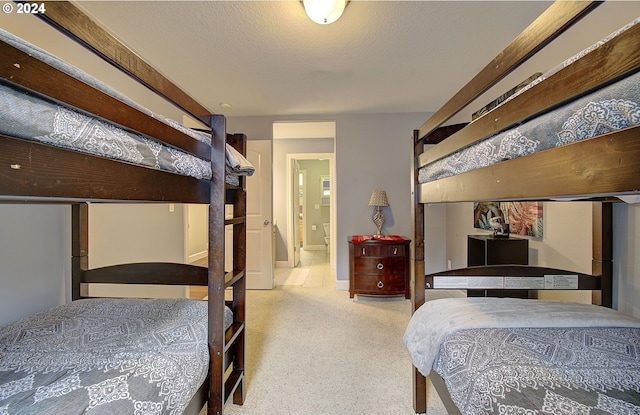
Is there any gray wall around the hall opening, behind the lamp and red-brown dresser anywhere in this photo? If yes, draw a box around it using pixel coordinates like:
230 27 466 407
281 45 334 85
227 113 427 288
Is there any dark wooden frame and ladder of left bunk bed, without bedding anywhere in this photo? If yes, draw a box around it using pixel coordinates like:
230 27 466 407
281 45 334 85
0 1 246 415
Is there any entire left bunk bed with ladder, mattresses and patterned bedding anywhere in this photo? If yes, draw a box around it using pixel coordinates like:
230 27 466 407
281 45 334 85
0 1 252 414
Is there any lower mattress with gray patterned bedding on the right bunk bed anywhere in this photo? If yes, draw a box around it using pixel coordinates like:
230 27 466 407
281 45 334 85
404 298 640 414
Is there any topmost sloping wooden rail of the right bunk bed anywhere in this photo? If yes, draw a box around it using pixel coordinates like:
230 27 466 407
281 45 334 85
419 1 599 138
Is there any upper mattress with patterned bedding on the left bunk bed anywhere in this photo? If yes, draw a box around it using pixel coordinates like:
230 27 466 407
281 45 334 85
0 29 253 185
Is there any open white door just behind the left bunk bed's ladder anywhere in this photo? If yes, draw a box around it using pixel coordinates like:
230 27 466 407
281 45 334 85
247 140 274 290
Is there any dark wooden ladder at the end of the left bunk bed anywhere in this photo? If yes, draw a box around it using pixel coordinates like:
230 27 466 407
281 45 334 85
207 115 246 415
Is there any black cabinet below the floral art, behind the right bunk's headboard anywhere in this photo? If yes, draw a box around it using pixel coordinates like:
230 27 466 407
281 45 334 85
467 235 530 298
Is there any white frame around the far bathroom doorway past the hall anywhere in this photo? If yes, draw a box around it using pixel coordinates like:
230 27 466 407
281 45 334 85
286 153 338 269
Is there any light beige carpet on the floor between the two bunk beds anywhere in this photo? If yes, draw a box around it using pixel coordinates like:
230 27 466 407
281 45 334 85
202 279 456 415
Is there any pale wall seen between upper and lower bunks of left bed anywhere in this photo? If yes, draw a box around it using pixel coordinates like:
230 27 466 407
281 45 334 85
0 204 186 325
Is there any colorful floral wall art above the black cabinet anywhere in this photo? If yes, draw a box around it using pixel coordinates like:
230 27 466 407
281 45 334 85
473 202 543 238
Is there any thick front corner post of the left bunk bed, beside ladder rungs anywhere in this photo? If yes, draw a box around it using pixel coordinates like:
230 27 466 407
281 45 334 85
207 115 227 415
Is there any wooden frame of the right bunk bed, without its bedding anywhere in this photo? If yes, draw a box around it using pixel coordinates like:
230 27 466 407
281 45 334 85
411 1 640 414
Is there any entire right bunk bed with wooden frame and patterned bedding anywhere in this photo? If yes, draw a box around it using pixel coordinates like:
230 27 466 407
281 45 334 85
403 1 640 414
